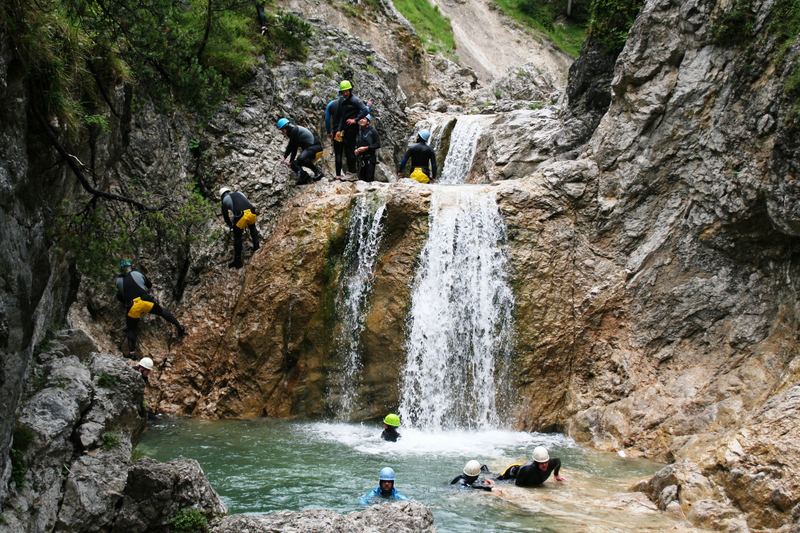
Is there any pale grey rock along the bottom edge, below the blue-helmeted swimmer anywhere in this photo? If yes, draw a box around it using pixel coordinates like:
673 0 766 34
213 502 436 533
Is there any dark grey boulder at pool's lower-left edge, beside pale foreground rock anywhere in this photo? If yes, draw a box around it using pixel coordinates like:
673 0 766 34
112 459 227 533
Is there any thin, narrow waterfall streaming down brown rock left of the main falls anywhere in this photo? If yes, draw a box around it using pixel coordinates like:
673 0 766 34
330 195 386 419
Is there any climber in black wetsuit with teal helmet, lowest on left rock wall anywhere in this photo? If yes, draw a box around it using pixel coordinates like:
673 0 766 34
115 259 186 360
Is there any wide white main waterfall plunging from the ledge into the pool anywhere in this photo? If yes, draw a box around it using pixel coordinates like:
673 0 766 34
400 187 514 429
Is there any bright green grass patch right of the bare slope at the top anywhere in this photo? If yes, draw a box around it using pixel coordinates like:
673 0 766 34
495 0 588 57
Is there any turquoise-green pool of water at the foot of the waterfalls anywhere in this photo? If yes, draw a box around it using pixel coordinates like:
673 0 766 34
137 419 688 532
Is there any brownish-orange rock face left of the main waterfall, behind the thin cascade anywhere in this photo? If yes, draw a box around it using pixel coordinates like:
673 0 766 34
154 180 429 417
